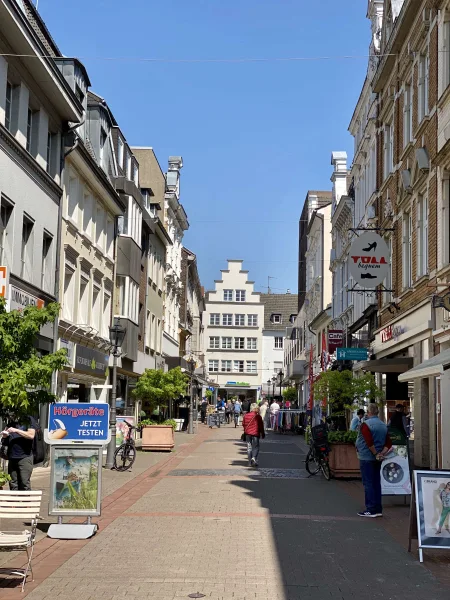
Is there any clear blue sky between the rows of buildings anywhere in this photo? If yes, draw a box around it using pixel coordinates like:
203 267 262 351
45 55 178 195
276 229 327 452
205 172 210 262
39 0 370 293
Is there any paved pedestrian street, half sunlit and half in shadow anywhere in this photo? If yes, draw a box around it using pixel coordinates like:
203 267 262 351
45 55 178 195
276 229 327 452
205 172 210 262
0 427 450 600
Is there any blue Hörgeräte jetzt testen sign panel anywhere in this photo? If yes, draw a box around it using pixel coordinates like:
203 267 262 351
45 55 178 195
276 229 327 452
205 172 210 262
45 402 110 445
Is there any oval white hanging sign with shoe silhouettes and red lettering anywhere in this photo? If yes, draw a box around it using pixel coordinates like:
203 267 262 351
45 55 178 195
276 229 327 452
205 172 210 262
348 231 391 288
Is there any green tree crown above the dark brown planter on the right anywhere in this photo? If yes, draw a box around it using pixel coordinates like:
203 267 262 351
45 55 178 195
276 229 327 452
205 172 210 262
313 371 382 415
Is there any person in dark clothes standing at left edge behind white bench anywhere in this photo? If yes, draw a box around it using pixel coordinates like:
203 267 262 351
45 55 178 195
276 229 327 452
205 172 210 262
2 417 40 491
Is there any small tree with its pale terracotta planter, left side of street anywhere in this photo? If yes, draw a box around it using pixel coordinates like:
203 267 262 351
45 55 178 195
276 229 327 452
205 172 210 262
133 367 189 451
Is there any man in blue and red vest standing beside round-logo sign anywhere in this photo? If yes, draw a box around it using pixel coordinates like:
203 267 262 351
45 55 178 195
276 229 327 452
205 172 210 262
356 403 392 517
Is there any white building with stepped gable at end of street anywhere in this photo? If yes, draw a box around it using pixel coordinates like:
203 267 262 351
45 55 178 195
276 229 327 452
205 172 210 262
204 260 264 400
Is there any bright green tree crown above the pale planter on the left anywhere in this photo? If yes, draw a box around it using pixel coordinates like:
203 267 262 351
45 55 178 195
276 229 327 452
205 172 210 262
133 367 189 413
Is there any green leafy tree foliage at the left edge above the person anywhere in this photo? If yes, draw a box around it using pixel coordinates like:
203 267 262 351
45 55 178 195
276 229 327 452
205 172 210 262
0 298 67 418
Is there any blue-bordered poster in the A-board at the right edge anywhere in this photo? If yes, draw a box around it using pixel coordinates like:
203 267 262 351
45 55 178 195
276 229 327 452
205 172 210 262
414 471 450 548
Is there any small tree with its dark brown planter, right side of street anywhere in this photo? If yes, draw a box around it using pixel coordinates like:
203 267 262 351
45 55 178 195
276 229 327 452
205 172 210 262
314 370 382 478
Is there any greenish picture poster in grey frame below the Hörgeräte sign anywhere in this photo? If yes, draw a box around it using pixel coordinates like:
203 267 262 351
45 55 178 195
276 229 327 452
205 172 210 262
49 446 101 516
